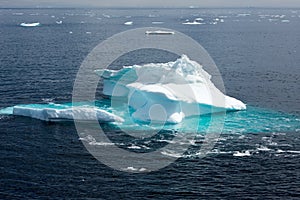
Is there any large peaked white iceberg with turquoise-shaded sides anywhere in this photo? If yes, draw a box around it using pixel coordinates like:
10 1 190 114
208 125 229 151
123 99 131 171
95 55 246 124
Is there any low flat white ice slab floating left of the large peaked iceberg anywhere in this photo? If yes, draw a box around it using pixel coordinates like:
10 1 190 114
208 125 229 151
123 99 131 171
12 104 124 122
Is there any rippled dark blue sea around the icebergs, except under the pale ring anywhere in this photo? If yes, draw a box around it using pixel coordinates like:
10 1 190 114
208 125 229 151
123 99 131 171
0 9 300 199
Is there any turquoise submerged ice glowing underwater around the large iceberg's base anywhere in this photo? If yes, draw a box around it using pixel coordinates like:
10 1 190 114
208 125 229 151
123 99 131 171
0 100 300 134
